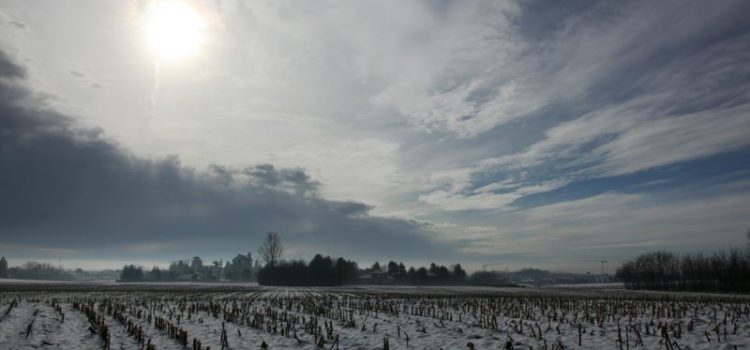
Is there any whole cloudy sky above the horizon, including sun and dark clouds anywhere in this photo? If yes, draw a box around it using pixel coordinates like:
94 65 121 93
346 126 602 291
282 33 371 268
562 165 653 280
0 0 750 272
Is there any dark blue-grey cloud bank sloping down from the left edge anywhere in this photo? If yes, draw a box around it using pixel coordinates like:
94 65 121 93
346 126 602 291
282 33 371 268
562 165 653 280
0 52 448 258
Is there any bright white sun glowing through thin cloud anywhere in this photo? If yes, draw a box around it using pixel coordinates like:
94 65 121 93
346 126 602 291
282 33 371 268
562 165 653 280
143 0 206 61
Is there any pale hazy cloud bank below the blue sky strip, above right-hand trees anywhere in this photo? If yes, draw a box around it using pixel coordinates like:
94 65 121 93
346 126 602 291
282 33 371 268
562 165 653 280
452 187 750 268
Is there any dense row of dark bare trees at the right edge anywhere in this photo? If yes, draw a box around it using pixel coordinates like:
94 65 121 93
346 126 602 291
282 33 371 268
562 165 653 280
616 249 750 293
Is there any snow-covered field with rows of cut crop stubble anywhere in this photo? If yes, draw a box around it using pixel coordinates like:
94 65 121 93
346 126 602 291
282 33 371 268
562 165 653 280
0 283 750 350
